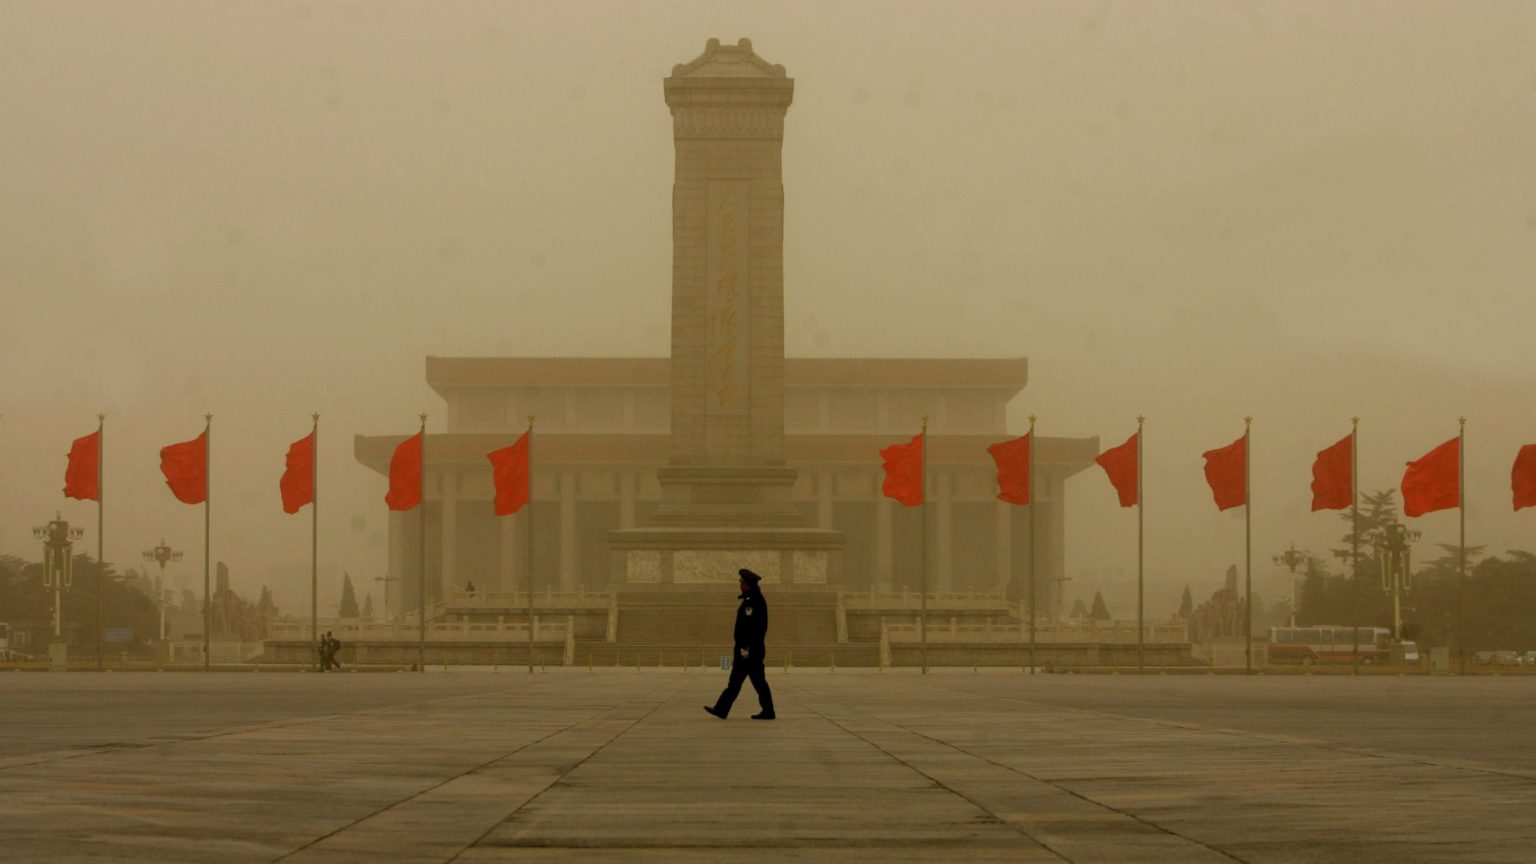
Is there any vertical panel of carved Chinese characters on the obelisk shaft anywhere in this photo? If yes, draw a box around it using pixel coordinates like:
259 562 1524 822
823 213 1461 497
703 180 751 415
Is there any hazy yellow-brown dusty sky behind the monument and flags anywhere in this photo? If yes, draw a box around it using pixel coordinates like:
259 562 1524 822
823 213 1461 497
0 0 1536 613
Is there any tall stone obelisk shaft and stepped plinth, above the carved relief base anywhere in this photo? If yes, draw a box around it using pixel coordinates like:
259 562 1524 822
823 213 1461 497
656 38 805 527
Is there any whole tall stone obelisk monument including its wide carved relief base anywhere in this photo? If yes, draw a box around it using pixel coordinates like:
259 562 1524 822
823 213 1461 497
610 38 843 589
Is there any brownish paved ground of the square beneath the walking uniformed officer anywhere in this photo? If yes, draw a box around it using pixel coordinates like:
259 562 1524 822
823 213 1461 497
0 669 1536 864
